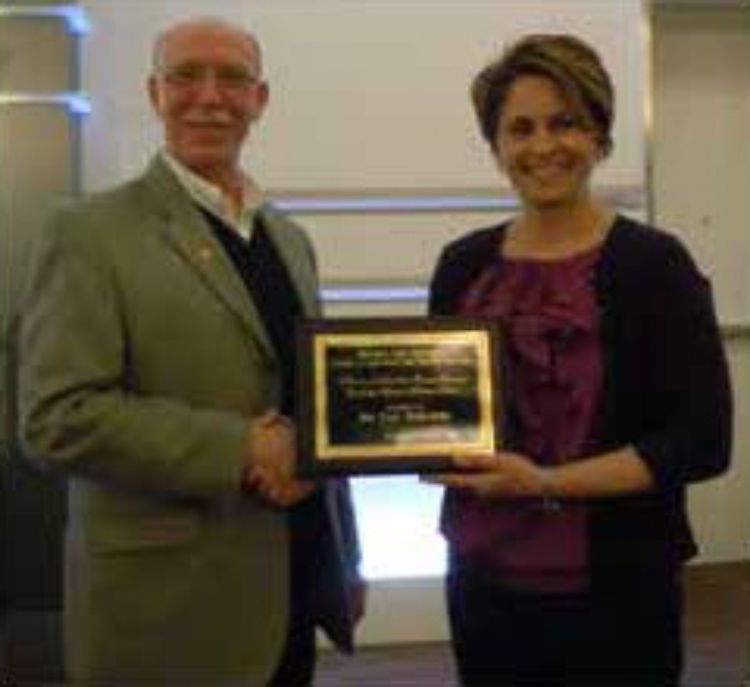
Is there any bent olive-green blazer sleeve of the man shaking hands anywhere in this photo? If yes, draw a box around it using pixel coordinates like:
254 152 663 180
18 204 247 498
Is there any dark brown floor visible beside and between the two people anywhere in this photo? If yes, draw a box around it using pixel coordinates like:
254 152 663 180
0 561 750 687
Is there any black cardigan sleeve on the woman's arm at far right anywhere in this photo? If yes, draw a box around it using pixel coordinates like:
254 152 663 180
634 237 732 491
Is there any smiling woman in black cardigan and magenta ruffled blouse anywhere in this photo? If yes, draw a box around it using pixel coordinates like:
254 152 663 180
430 35 731 687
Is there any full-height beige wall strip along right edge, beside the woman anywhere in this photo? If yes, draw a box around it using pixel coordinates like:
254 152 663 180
652 3 750 561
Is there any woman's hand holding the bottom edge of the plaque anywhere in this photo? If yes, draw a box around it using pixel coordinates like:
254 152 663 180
422 452 548 498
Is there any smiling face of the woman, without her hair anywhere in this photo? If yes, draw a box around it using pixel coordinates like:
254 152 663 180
494 75 601 209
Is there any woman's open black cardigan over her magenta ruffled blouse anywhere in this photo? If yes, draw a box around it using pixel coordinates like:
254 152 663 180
429 216 732 593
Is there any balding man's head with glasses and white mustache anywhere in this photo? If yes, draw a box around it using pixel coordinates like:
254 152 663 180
148 24 268 178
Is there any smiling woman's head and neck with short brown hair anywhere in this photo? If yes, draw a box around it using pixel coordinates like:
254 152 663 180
472 35 614 257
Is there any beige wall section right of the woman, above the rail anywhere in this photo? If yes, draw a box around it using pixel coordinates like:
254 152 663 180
652 4 750 324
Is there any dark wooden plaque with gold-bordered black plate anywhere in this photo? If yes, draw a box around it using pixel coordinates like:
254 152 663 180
297 318 502 478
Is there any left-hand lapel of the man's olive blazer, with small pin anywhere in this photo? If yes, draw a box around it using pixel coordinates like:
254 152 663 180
137 158 276 359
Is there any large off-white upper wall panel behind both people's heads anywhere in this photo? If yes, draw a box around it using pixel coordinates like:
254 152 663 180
81 0 643 192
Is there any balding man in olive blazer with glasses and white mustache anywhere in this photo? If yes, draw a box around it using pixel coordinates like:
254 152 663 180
19 19 363 687
